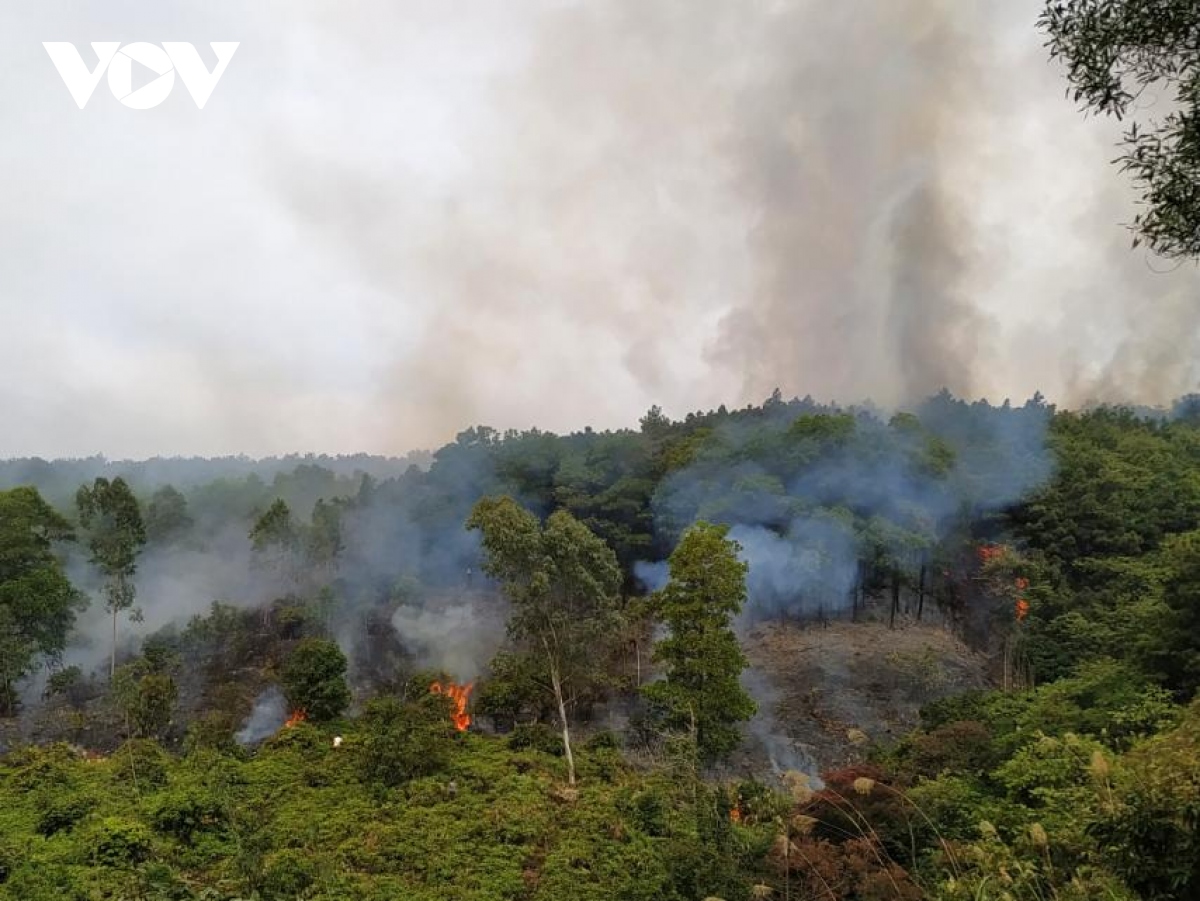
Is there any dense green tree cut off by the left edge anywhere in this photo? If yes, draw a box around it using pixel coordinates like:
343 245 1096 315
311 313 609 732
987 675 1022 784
0 488 84 711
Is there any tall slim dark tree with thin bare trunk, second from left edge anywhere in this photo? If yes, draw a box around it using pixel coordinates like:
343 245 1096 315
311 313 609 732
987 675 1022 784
76 477 146 677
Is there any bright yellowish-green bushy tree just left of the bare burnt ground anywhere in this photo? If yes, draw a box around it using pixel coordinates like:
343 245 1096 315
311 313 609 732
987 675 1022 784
642 522 755 761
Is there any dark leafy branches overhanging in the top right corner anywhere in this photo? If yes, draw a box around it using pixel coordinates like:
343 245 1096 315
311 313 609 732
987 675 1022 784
1040 0 1200 257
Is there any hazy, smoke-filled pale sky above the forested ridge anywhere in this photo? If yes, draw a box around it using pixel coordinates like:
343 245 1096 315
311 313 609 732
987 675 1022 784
0 0 1200 457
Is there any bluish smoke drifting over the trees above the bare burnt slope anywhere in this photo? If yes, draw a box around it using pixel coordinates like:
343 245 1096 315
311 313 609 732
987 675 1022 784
648 395 1054 629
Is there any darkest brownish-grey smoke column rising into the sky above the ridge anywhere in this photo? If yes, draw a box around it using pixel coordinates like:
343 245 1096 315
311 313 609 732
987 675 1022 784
715 1 988 403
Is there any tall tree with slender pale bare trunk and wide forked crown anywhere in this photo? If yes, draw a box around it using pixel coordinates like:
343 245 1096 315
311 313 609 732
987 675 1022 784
467 497 622 785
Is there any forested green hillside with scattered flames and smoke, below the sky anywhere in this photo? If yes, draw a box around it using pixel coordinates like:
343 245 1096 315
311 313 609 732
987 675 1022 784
0 396 1200 901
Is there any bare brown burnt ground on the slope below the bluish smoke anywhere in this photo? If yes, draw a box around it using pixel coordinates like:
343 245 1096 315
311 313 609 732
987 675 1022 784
738 623 988 773
